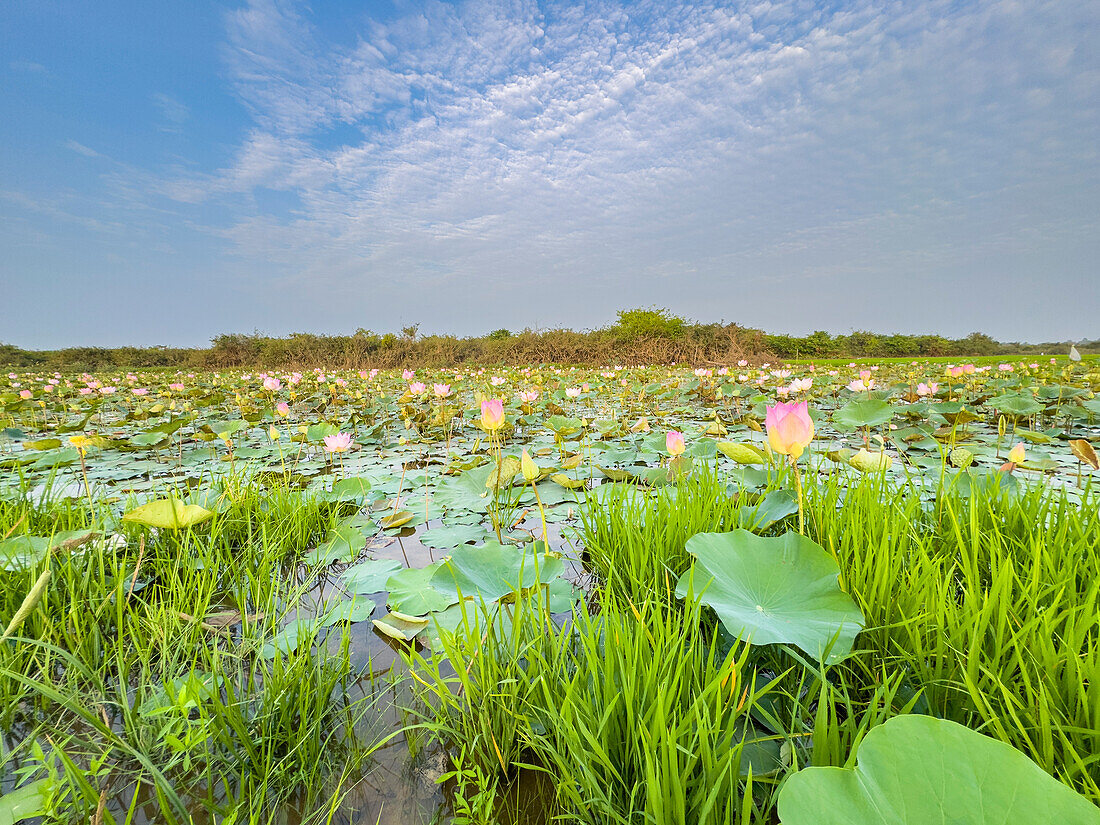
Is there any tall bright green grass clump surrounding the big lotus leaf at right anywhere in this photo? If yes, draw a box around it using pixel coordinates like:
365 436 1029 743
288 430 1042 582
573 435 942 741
413 469 1100 824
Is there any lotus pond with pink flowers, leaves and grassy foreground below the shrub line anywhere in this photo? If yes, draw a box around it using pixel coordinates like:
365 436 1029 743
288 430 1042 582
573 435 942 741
0 358 1100 825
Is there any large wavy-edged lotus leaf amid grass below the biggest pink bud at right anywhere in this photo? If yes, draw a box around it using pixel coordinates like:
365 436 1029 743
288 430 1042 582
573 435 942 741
677 530 864 662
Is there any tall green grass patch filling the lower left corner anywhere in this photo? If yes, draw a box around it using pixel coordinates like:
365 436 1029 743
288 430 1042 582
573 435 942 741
0 479 396 823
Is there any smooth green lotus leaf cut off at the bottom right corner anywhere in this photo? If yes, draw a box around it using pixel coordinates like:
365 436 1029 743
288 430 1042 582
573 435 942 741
779 715 1100 825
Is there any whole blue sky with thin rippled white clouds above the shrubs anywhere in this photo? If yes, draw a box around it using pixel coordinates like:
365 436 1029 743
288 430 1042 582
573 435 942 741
0 0 1100 349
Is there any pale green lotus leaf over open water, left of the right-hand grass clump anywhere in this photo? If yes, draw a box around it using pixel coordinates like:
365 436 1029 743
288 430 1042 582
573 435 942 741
431 541 565 602
